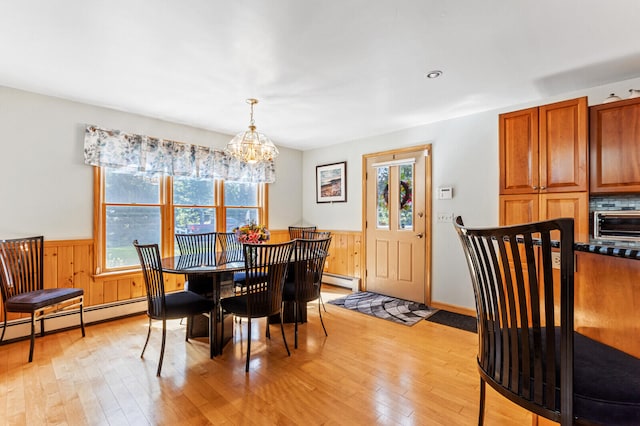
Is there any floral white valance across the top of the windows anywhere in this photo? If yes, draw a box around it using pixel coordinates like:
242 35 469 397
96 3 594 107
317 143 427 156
84 125 276 183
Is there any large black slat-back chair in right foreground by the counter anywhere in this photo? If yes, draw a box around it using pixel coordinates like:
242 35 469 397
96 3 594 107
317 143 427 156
454 217 640 425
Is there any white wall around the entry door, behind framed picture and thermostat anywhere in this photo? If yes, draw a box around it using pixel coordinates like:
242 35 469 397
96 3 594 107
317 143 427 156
302 78 640 309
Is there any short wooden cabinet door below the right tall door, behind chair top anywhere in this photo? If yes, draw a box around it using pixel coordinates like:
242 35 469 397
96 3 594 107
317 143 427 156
540 192 589 241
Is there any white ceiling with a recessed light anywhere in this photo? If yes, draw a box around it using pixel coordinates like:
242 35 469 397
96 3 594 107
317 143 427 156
0 0 640 150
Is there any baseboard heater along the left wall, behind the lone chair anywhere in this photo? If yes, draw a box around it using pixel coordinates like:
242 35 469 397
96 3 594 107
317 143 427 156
0 297 147 340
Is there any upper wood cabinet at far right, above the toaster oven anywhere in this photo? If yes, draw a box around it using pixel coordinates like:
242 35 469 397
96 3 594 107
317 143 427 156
590 98 640 193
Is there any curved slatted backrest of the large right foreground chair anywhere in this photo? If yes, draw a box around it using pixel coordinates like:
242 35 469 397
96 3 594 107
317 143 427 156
456 218 574 421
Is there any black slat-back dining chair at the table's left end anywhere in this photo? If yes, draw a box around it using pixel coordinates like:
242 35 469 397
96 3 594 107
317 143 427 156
133 240 217 376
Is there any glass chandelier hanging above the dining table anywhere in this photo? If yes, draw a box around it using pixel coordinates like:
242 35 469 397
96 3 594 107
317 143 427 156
225 99 278 164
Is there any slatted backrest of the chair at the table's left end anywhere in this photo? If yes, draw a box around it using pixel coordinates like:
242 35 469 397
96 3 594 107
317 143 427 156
133 240 166 319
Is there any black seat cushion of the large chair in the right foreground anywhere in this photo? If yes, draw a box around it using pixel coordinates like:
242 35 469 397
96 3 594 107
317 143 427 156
573 333 640 425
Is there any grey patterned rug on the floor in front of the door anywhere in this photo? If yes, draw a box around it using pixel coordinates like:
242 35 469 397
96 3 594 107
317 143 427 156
327 291 435 326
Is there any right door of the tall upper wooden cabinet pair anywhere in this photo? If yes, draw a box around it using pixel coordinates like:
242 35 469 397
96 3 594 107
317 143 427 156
538 97 589 193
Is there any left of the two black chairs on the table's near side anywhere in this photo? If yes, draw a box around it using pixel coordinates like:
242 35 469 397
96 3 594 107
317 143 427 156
220 241 294 372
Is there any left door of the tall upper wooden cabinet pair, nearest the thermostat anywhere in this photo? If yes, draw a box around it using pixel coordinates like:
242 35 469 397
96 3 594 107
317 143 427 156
499 107 538 194
